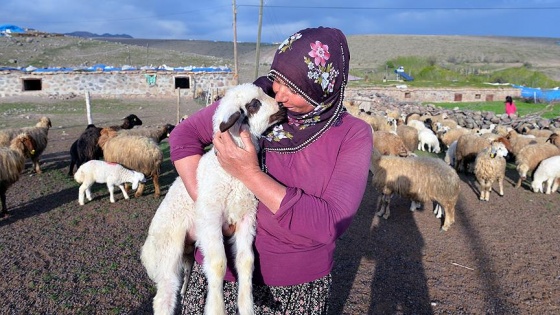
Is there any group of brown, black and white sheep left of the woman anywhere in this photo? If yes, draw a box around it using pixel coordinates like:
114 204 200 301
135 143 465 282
0 111 175 217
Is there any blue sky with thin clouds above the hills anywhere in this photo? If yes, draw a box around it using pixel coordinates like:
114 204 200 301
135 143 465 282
0 0 560 43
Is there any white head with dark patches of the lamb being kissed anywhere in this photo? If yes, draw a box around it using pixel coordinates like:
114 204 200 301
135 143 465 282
213 83 286 145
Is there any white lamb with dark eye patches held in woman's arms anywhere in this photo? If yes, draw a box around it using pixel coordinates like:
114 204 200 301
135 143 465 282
141 83 285 314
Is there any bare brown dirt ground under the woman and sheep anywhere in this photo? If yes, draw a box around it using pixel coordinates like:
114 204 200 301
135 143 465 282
0 97 560 314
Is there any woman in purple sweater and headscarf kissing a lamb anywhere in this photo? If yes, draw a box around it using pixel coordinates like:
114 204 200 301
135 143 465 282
169 27 373 314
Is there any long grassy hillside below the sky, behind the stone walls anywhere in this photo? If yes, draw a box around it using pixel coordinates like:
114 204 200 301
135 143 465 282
0 35 560 82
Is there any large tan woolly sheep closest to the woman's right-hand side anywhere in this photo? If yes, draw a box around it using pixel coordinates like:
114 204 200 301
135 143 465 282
370 148 460 231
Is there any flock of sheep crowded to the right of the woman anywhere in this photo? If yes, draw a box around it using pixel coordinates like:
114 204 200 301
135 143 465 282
346 102 560 230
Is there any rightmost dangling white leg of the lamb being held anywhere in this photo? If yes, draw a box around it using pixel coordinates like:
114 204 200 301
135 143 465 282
235 214 255 315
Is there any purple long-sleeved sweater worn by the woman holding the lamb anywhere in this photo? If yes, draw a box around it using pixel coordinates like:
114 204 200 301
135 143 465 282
169 104 373 286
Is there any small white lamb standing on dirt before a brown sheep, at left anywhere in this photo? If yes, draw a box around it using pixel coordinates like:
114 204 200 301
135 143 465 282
74 160 146 206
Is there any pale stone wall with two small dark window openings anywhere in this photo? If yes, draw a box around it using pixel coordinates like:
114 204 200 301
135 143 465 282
0 71 236 98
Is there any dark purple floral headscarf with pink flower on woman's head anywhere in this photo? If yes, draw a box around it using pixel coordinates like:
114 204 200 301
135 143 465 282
263 27 350 153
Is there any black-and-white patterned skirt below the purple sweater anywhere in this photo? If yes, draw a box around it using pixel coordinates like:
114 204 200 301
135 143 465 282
181 262 332 315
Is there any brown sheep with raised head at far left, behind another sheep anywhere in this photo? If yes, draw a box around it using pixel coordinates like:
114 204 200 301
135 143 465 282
0 116 52 174
